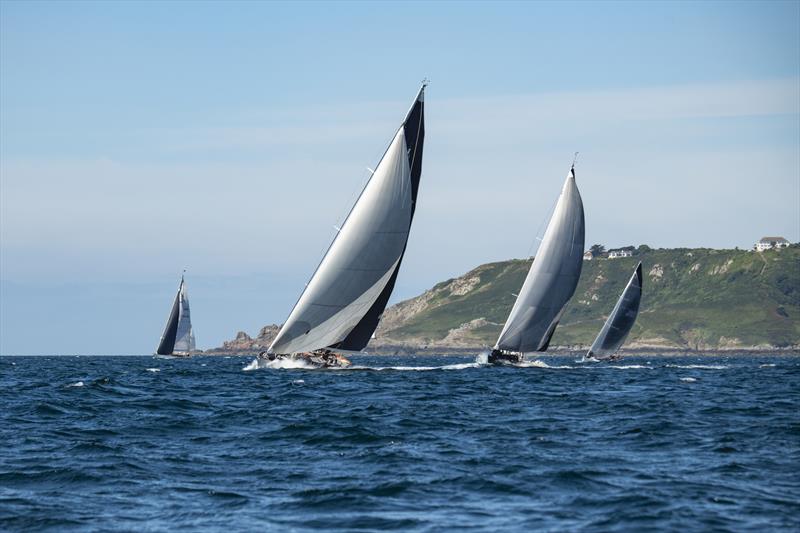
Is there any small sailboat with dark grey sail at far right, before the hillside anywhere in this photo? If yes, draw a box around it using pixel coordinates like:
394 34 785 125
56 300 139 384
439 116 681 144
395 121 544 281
586 263 642 360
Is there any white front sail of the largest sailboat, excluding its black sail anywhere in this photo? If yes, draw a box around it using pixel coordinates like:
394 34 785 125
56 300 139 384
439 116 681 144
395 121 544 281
269 127 412 353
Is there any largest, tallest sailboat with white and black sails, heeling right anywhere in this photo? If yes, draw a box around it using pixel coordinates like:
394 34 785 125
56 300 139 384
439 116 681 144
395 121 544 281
259 82 426 367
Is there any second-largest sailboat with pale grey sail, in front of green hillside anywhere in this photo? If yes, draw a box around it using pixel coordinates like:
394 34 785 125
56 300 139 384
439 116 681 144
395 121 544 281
488 162 585 364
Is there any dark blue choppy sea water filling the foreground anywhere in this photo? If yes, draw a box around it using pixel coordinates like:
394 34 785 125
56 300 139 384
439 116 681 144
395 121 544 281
0 356 800 531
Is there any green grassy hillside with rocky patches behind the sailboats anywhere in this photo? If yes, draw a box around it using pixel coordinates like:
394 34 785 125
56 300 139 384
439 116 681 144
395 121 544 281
377 246 800 349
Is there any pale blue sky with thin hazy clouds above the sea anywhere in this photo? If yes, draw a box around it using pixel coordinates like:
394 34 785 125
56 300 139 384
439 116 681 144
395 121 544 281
0 1 800 354
